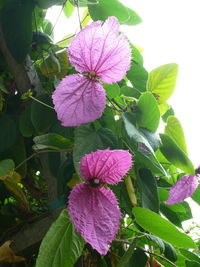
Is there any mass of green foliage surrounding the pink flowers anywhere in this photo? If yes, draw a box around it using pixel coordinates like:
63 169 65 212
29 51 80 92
0 0 200 267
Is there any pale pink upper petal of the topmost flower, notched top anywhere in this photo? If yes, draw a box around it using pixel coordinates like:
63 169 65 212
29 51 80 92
68 17 131 83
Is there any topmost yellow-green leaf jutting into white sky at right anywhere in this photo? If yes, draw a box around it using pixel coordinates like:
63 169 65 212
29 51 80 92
147 63 178 104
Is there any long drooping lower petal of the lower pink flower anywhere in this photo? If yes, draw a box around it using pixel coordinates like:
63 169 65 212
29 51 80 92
68 183 121 255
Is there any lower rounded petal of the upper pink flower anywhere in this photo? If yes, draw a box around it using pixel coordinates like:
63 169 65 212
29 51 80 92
52 74 105 126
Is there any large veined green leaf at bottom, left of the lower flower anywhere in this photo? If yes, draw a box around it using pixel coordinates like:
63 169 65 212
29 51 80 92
36 210 84 267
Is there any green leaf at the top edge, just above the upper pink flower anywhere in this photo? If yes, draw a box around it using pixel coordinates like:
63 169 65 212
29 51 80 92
88 0 142 25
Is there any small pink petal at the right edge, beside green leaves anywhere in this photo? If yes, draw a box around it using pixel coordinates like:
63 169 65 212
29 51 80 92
164 175 198 205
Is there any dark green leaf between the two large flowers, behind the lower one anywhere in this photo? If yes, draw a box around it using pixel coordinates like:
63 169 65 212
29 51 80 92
73 124 117 173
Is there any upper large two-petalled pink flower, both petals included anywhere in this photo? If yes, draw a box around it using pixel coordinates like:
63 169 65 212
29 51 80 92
52 17 131 126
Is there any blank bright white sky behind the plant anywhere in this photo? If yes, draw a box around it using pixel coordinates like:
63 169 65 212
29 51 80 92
46 0 200 225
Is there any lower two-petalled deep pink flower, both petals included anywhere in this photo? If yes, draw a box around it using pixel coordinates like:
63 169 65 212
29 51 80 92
68 149 132 255
